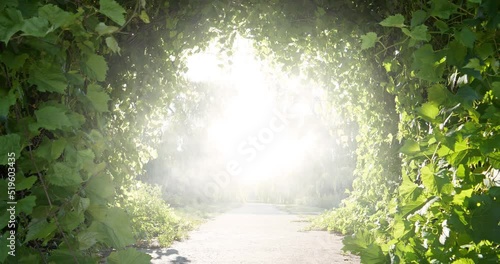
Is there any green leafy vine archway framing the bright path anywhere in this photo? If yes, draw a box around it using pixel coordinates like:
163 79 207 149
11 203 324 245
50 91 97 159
0 0 500 263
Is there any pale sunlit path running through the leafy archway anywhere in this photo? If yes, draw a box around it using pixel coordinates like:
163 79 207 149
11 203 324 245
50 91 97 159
144 203 359 264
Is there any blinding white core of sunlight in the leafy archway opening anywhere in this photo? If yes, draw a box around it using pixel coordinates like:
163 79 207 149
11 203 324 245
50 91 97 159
187 38 317 185
